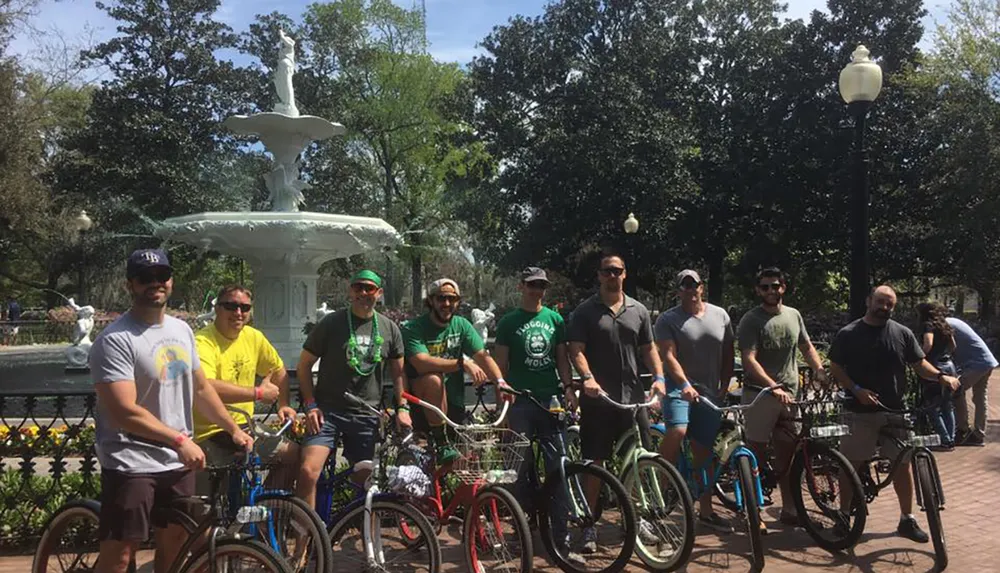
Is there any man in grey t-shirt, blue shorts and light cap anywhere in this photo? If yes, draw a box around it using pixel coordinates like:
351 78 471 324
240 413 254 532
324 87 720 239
654 269 735 533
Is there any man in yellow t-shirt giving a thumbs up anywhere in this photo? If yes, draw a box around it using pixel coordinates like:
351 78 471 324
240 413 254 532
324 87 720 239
194 285 299 488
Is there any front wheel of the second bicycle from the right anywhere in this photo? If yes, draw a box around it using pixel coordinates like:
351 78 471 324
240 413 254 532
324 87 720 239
791 441 868 553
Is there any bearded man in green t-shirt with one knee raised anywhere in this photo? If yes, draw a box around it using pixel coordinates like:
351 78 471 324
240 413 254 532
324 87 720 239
401 278 506 464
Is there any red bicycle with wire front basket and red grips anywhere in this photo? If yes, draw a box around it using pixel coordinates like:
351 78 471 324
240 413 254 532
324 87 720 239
403 386 534 573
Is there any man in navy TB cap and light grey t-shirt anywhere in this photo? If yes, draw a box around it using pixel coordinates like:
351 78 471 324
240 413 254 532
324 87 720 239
90 249 253 572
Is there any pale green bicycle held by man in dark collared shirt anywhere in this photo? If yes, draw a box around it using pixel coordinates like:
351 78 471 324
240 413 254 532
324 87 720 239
599 390 694 571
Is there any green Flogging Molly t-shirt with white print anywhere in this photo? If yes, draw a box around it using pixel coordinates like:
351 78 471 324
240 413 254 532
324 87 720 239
497 307 565 398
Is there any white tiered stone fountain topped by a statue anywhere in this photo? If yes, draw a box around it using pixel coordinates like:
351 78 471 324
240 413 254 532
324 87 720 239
157 32 401 369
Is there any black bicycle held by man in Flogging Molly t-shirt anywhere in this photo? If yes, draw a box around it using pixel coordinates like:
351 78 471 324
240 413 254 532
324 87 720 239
504 388 636 573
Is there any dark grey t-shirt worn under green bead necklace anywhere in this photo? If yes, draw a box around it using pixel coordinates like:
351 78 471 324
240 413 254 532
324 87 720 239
302 309 403 411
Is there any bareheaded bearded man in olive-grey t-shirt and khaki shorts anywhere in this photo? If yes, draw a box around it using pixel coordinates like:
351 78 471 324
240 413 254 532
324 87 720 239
737 267 827 527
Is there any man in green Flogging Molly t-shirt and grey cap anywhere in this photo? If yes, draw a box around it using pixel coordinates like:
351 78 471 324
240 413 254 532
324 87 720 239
494 267 576 556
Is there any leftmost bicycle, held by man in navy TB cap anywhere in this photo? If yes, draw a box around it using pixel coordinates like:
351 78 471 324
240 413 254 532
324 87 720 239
32 467 290 573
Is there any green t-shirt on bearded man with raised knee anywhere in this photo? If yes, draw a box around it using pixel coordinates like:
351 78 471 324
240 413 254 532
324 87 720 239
403 314 485 408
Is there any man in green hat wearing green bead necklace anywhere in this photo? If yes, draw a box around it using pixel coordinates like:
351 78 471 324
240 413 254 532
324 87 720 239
296 270 410 507
